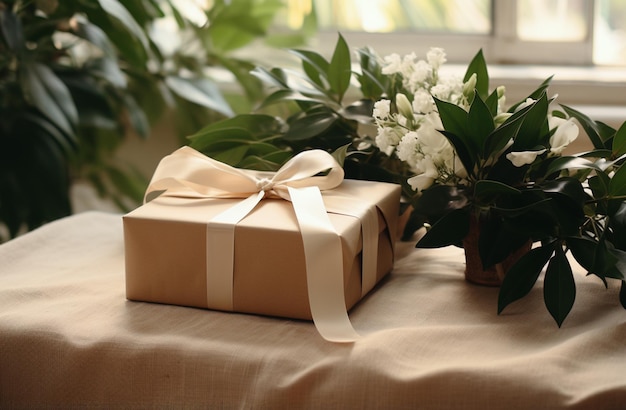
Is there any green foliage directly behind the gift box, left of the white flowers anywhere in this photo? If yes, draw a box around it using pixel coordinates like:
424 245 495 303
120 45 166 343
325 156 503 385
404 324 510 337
189 36 410 192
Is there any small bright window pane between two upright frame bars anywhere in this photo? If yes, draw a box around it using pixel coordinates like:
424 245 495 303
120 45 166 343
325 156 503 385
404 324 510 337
517 0 587 42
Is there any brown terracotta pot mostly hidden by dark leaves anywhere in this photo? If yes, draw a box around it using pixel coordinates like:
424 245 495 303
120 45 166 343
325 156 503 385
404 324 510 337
463 213 532 286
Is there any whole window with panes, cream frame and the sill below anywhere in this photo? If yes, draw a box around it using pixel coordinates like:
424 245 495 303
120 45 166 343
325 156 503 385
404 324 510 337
285 0 626 117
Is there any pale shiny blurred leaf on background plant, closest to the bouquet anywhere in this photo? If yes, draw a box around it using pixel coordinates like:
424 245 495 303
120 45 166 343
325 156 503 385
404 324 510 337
165 75 234 116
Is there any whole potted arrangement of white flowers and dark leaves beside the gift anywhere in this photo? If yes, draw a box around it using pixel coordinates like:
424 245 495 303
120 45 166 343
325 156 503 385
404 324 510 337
191 36 626 326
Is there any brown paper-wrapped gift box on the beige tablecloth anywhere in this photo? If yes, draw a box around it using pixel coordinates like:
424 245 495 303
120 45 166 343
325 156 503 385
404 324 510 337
123 147 400 342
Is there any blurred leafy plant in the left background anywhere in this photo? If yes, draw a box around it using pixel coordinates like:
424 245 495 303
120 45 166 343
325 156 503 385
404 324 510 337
0 0 315 242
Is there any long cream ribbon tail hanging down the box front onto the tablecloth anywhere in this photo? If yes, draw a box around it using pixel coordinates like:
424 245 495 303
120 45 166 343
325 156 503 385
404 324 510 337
289 187 359 343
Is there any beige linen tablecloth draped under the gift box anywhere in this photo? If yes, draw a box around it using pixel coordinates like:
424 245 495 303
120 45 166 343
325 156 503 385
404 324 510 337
0 213 626 409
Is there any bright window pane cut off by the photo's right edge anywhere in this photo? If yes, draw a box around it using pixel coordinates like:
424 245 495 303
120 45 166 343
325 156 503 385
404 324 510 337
593 0 626 65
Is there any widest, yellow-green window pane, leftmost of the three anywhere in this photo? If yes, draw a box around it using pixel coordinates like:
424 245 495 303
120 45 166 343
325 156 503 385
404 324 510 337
287 0 491 34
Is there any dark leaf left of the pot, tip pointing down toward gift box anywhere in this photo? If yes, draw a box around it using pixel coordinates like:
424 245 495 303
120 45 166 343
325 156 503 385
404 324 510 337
415 208 469 248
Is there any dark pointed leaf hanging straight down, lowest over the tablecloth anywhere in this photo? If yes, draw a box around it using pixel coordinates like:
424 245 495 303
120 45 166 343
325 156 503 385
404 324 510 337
543 247 576 327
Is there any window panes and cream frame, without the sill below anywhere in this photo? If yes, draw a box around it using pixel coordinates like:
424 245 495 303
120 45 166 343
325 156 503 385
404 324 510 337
287 0 626 65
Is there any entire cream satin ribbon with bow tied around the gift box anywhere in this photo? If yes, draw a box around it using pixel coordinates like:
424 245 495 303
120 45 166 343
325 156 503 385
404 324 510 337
144 147 378 342
